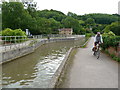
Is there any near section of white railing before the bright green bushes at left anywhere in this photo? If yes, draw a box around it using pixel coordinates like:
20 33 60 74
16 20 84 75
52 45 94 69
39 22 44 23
0 36 30 52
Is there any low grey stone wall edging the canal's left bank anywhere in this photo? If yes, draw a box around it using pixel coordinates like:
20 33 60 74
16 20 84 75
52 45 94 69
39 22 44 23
0 38 79 63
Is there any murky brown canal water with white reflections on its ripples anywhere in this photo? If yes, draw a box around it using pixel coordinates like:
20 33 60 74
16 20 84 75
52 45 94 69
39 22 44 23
2 38 85 88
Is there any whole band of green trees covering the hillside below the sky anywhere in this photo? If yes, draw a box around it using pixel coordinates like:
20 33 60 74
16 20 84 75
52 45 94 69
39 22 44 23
0 2 120 35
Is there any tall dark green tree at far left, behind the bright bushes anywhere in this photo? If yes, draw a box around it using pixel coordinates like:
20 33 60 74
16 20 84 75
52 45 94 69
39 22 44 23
2 2 32 30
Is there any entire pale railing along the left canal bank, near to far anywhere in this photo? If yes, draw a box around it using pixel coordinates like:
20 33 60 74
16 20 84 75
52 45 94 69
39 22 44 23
0 34 85 52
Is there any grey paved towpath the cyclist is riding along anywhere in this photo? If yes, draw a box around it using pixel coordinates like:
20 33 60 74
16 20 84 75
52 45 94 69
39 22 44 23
61 38 118 88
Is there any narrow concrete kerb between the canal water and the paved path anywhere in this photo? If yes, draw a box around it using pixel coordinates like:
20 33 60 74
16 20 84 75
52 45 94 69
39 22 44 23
48 38 90 88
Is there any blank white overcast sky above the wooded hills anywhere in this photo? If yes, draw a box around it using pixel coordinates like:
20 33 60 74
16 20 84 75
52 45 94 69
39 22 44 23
34 0 120 15
